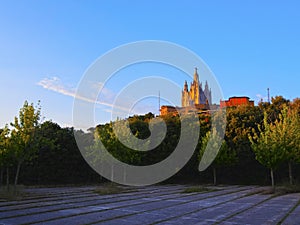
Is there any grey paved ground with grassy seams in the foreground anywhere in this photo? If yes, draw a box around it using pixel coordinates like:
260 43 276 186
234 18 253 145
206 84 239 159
0 185 300 225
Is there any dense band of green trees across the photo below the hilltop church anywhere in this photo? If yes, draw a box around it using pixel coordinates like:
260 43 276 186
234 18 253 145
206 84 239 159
0 96 300 187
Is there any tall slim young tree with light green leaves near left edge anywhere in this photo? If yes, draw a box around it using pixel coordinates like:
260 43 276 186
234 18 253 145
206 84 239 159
11 101 41 186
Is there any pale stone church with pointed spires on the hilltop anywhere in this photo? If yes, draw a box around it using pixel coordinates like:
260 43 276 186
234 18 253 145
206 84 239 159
181 68 212 107
